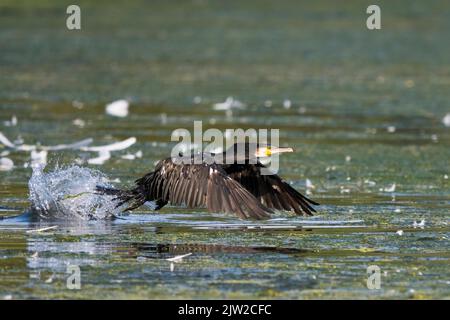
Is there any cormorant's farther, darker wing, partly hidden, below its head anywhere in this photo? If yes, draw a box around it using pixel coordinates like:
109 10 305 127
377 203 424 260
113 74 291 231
225 163 319 216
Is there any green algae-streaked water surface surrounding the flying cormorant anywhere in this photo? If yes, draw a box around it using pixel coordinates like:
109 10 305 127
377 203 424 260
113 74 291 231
0 0 450 299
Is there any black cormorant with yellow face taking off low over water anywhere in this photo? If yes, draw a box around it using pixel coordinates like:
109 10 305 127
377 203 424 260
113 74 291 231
97 142 319 219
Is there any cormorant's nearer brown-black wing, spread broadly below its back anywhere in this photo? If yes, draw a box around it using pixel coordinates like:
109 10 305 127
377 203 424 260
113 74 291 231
131 158 272 219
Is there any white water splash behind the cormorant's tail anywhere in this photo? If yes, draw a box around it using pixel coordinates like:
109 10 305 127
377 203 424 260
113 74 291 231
28 165 122 220
